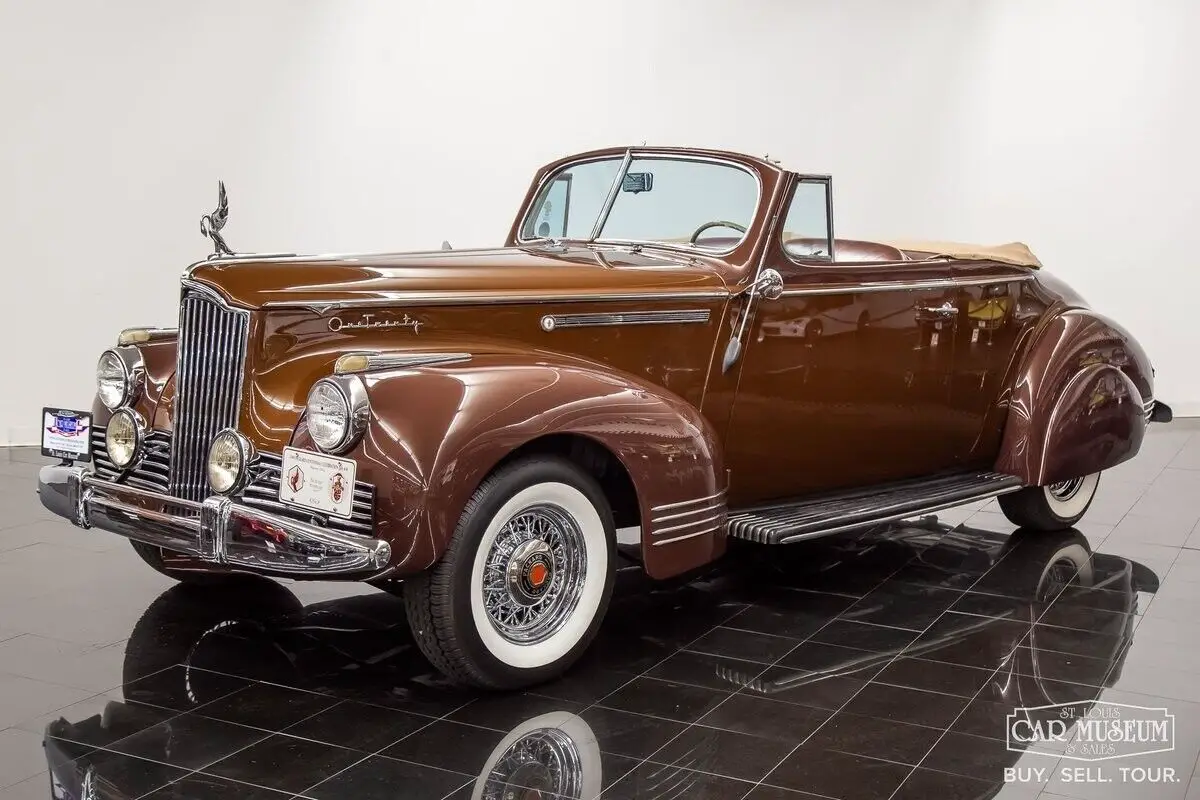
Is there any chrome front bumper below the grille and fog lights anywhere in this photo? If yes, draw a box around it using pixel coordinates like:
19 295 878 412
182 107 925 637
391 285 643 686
37 465 391 576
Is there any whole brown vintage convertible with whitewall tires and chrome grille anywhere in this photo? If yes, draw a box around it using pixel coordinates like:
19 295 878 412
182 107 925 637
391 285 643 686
38 148 1171 687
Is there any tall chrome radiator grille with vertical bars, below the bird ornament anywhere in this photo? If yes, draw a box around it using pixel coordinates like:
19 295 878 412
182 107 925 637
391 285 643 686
170 289 250 501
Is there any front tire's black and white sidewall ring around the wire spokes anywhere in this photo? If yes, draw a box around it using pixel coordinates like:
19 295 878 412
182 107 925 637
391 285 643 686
451 458 616 687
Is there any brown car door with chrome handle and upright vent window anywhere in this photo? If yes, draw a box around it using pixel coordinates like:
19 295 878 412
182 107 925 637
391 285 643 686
726 178 956 506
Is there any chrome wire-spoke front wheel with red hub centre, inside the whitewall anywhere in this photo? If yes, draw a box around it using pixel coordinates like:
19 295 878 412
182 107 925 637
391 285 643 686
484 505 587 644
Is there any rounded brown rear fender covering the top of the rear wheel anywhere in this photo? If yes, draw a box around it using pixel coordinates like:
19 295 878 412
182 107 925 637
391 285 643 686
996 309 1153 486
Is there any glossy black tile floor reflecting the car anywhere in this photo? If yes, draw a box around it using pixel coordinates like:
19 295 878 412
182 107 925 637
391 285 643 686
0 421 1200 800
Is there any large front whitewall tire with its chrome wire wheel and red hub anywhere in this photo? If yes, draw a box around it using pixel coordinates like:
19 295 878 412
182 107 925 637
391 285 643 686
404 457 616 688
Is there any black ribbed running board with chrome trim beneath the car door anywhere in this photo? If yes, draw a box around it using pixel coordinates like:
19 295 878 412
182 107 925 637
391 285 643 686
730 473 1022 545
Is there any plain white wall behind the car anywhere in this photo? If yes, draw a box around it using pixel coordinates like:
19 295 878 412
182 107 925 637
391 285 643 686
0 0 1200 443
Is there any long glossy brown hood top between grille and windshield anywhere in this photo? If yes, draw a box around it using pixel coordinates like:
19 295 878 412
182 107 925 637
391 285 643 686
190 247 726 308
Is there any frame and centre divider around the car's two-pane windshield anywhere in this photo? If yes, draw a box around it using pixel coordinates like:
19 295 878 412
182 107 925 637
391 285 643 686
514 148 763 255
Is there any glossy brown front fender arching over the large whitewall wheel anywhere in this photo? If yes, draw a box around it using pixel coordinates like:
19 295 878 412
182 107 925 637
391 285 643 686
338 354 725 578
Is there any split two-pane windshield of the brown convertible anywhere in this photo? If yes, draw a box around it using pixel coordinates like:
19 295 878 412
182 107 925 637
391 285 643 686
521 156 758 251
